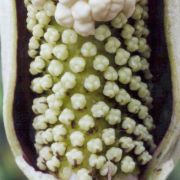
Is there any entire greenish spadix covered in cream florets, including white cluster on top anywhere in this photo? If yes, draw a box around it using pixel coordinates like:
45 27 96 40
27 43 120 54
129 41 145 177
25 0 155 180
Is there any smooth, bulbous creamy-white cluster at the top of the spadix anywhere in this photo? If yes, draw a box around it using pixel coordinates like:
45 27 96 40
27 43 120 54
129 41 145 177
55 0 138 36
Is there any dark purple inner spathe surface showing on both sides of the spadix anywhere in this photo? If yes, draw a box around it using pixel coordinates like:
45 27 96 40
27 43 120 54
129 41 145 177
14 0 172 175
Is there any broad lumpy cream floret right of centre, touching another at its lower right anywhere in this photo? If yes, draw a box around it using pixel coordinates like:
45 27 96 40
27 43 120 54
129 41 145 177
91 101 109 118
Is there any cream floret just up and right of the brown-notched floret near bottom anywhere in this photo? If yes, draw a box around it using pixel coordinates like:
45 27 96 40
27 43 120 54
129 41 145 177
87 138 103 153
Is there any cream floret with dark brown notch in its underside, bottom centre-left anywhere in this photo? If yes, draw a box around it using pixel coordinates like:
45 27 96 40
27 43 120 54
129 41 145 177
66 149 84 166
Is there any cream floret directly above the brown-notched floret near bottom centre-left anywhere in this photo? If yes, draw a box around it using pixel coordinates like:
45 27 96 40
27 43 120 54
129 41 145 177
70 131 85 147
